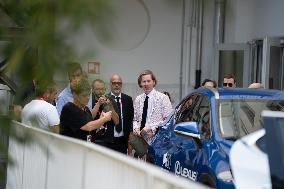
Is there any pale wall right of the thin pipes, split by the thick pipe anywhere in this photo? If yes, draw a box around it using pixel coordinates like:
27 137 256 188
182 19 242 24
201 0 284 87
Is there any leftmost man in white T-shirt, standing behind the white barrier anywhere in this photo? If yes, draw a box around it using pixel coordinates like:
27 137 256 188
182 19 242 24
21 83 60 133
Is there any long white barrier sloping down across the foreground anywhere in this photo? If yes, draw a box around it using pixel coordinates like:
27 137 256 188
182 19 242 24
6 122 205 189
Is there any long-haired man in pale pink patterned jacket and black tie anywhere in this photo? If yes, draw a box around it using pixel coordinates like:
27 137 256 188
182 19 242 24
133 70 172 144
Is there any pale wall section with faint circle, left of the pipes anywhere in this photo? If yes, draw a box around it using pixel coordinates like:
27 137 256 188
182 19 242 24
63 0 182 102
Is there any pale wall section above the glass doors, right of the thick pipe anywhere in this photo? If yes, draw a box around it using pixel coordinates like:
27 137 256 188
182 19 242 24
225 0 284 43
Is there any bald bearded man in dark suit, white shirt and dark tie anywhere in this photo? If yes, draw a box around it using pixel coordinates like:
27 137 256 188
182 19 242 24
110 74 134 154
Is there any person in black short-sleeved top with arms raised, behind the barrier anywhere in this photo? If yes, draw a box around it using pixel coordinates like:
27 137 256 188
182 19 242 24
60 78 112 142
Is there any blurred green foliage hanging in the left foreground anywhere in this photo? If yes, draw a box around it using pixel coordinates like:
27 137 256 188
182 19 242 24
0 0 113 183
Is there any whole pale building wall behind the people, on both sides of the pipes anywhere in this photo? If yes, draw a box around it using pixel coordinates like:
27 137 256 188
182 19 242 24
55 0 284 103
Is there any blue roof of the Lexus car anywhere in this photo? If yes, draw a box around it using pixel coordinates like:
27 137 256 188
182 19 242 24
191 87 284 100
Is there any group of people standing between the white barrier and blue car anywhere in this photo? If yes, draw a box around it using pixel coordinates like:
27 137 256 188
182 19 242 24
21 63 172 155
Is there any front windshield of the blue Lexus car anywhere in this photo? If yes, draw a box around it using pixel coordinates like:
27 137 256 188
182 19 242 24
219 99 284 140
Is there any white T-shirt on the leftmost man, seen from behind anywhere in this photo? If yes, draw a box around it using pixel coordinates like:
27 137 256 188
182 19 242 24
21 99 60 130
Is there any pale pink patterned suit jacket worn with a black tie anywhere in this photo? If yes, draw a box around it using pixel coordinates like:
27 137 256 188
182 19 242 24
133 89 172 143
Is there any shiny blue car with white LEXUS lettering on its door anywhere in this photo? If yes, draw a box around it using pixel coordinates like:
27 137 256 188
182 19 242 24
147 87 284 189
